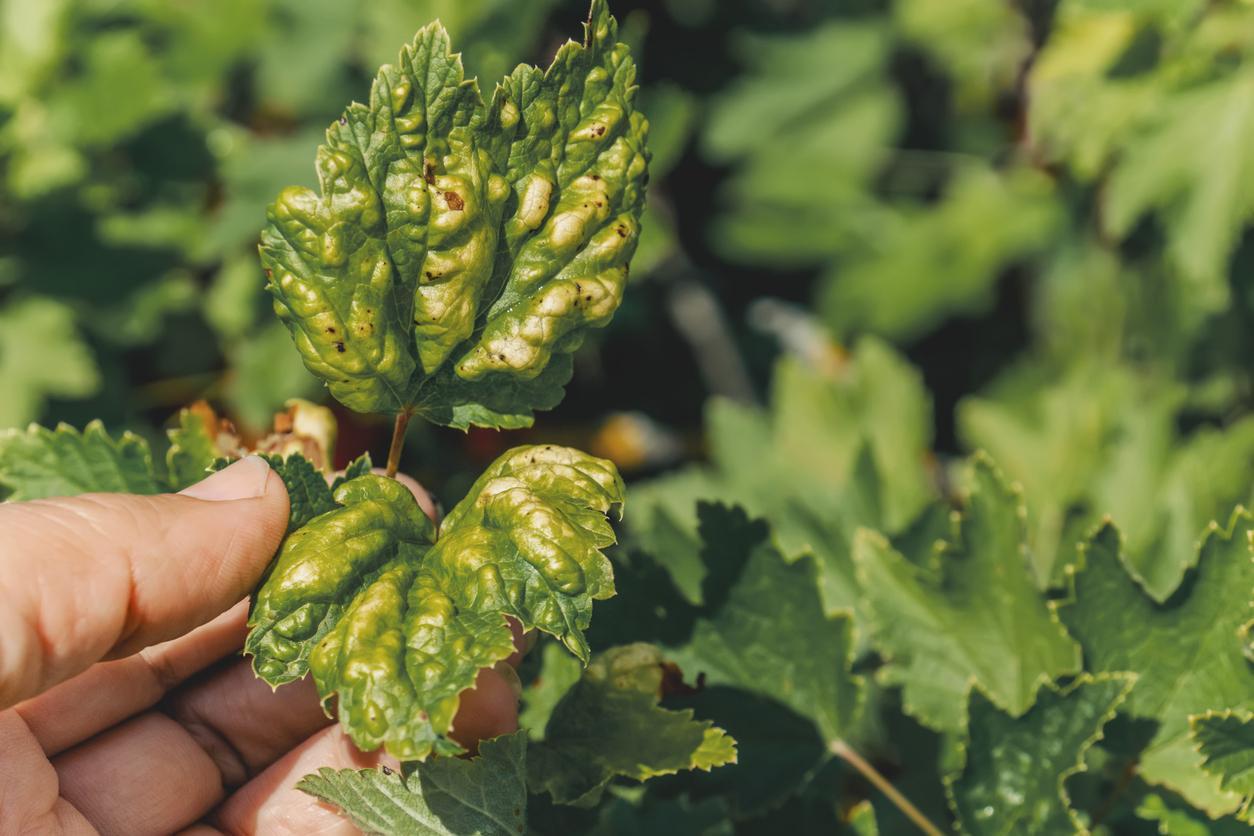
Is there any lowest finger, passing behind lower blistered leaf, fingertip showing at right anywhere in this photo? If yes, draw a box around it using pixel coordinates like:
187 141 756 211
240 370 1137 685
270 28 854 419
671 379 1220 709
213 668 518 835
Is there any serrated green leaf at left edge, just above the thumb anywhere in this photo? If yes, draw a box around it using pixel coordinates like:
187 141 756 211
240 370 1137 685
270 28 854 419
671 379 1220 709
0 421 162 501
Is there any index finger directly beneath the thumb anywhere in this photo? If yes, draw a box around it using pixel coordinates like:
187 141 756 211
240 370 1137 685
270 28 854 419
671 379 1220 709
18 600 248 756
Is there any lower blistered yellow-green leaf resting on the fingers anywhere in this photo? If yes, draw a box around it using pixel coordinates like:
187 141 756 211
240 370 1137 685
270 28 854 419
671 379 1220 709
245 445 623 760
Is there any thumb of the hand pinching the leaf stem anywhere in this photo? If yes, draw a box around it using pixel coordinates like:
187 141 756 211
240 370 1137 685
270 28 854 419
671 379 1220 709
0 456 288 708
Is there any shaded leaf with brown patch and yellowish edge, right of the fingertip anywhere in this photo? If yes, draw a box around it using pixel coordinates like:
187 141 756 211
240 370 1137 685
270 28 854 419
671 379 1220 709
527 644 736 806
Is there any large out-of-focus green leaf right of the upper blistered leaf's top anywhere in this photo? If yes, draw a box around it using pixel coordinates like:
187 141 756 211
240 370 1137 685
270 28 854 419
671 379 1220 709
703 23 900 268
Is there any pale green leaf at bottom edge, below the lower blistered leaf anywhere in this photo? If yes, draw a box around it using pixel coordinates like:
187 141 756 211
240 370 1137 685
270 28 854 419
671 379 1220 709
296 732 527 836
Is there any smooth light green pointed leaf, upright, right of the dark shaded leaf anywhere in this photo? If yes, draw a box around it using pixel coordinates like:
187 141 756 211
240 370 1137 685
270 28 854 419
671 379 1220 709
854 454 1080 731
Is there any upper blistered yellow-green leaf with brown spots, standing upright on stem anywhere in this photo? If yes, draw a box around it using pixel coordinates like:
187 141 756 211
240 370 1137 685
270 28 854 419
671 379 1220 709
261 0 648 429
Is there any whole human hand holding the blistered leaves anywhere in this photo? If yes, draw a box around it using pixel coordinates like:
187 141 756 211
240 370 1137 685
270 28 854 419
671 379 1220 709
0 456 518 836
